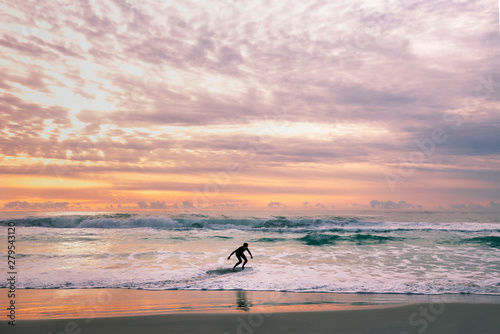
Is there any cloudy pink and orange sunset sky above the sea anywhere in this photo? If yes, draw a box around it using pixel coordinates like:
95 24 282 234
0 0 500 209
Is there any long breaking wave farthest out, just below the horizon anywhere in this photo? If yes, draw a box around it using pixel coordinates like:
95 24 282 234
0 213 500 232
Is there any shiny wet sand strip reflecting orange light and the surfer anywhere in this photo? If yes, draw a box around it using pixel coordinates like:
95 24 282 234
0 288 500 320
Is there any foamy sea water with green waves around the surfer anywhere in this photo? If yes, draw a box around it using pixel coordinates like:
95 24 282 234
0 211 500 295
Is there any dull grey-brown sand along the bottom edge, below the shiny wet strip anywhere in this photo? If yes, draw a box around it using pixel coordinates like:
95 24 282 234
0 303 500 334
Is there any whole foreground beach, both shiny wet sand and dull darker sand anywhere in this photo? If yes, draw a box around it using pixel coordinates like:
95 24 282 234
0 289 500 334
